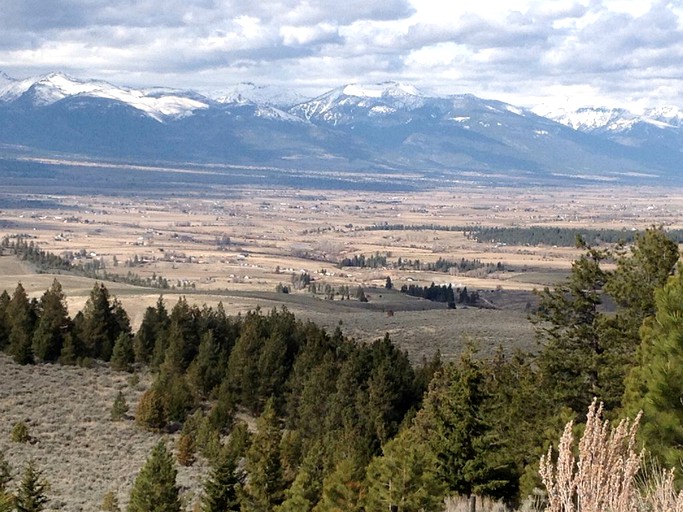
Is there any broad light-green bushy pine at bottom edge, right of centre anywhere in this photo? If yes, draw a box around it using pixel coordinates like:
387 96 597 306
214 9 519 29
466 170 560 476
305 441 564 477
365 430 445 512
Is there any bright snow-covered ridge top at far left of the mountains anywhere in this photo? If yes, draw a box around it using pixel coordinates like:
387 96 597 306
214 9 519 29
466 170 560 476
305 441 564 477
0 73 209 121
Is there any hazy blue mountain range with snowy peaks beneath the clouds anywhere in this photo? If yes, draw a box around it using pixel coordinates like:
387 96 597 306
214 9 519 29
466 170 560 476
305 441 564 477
0 73 683 189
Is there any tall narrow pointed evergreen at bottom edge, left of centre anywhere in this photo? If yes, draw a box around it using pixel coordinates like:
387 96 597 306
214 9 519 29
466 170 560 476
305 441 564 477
242 399 285 512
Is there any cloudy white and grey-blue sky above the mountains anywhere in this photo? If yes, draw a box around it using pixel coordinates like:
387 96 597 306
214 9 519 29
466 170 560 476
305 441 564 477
0 0 683 112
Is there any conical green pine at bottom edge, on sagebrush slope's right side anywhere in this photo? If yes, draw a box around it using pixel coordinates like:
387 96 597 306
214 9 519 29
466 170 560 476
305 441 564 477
127 441 181 512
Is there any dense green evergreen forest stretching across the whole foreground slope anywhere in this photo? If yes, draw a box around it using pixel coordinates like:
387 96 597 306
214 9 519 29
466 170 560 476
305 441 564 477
0 228 683 512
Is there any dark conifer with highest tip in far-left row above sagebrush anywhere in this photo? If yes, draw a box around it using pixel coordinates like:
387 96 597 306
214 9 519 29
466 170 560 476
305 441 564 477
33 279 71 361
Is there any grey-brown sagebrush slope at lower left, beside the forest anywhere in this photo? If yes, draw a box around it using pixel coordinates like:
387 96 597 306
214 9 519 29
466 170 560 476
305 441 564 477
0 354 207 512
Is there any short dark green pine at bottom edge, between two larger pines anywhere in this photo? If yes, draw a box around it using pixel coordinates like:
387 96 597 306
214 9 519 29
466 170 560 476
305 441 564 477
202 449 240 512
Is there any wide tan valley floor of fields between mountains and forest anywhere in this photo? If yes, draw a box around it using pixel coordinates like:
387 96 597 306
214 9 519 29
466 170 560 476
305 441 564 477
0 187 683 359
